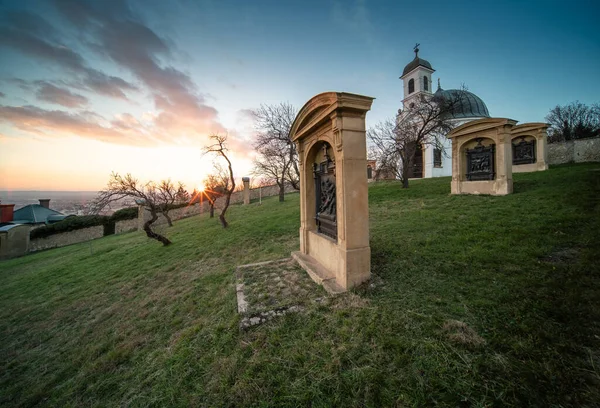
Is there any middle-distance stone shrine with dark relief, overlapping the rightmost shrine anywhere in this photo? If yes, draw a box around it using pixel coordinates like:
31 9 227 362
448 118 517 195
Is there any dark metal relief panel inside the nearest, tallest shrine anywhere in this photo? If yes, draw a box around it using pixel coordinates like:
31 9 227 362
313 144 337 239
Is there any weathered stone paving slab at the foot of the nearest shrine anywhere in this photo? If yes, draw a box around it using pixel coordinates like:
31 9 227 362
236 258 327 329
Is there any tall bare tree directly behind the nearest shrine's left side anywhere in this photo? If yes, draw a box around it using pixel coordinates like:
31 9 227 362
253 103 300 191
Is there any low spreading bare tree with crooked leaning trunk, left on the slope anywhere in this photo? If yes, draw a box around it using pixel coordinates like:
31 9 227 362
92 173 187 246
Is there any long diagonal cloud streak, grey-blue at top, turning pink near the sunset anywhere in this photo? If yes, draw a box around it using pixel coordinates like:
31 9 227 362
55 0 225 133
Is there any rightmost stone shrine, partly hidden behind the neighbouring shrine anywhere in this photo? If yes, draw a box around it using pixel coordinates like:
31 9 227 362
511 123 549 173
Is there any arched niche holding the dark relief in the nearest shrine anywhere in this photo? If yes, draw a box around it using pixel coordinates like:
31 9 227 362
304 140 338 240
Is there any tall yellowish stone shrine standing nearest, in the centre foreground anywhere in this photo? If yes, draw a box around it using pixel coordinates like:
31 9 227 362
290 92 374 293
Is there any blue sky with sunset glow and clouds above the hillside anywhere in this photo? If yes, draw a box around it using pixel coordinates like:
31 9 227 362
0 0 600 190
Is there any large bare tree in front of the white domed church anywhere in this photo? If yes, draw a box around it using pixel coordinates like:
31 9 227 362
367 90 464 188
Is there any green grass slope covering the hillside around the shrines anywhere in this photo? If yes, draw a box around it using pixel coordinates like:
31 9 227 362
0 164 600 407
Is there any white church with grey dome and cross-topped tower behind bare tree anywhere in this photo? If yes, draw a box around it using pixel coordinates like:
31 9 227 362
399 44 490 178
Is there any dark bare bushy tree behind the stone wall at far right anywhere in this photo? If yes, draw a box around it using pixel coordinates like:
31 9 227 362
546 101 600 143
